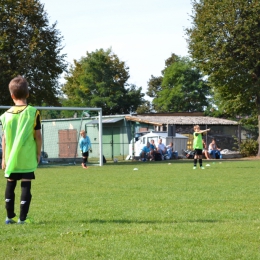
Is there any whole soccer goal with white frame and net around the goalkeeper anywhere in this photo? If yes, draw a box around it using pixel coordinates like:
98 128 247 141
0 106 103 166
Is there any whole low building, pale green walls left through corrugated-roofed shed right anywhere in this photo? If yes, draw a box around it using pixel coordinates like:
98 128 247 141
20 113 241 159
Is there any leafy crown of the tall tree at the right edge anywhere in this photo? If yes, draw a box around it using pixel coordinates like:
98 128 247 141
187 0 260 155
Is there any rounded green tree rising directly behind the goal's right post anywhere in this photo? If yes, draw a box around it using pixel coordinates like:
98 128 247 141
62 49 144 115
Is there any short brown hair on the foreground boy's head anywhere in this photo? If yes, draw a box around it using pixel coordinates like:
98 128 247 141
9 75 29 99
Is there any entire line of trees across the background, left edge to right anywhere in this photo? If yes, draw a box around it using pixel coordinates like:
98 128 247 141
0 0 260 153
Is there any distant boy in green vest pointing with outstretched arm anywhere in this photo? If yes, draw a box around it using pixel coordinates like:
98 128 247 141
193 125 210 170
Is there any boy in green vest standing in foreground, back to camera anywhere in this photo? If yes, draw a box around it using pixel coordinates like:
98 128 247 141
0 76 42 224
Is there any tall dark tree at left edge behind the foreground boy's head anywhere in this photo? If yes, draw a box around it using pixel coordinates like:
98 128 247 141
0 0 67 105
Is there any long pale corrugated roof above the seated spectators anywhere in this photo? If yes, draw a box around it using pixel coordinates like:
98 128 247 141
125 114 239 125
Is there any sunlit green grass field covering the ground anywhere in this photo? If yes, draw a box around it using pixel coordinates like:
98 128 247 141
0 160 260 260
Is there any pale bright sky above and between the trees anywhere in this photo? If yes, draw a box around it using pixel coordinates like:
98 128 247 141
40 0 192 99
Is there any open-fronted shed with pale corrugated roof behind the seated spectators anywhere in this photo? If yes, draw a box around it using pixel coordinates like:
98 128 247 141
125 112 243 150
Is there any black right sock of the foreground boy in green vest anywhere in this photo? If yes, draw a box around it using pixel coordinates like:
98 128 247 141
20 181 32 221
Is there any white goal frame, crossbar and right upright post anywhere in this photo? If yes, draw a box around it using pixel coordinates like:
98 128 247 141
0 106 103 166
